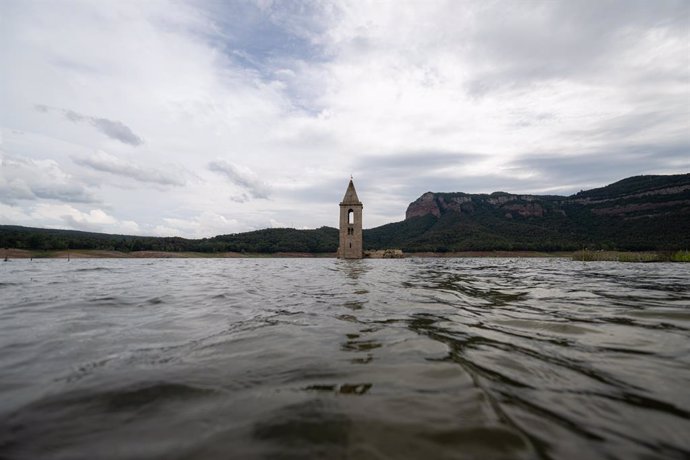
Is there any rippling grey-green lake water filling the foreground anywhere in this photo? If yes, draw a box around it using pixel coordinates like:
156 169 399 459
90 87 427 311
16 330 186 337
0 259 690 459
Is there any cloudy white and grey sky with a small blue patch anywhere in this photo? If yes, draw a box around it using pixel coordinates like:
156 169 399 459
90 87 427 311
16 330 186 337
0 0 690 237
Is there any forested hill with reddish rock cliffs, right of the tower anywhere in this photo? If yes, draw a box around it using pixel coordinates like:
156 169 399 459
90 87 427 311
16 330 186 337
365 174 690 252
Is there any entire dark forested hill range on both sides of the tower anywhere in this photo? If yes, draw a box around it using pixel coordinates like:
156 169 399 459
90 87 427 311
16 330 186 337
0 174 690 253
